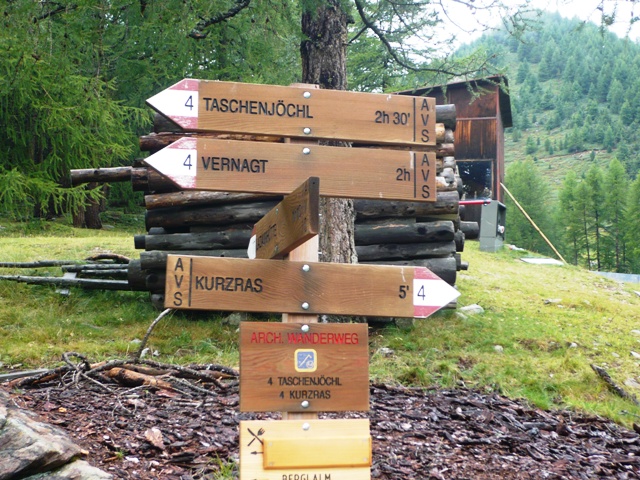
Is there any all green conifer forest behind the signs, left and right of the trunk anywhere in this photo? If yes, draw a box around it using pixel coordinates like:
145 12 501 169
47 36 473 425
0 0 640 273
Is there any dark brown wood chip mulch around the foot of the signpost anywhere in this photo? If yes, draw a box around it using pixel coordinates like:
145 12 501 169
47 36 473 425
5 381 640 480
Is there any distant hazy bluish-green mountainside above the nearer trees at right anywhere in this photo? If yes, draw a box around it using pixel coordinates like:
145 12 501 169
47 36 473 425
463 14 640 187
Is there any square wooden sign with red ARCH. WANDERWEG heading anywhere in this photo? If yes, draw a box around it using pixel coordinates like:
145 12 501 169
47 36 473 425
240 322 369 412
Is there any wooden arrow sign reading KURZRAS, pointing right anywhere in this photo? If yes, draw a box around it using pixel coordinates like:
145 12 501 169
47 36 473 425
165 255 459 318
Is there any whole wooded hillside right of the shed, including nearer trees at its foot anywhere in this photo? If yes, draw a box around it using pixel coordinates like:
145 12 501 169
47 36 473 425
452 14 640 273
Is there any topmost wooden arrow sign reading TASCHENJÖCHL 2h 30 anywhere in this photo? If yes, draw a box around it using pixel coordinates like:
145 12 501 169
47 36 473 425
147 79 436 145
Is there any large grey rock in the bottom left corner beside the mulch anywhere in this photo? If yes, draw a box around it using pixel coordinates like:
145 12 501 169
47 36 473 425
0 392 112 480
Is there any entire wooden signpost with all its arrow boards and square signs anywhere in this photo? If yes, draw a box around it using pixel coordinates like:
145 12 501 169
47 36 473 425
146 79 458 480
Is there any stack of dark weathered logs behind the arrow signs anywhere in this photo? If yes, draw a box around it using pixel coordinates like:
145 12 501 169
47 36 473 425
70 105 466 308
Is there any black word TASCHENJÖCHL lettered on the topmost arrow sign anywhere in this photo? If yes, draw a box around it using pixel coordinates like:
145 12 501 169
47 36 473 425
203 97 313 118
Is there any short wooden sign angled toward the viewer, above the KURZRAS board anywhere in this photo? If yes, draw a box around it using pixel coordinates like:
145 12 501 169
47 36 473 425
248 177 320 258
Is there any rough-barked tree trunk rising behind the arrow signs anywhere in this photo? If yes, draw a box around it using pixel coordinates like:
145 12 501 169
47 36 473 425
300 0 358 263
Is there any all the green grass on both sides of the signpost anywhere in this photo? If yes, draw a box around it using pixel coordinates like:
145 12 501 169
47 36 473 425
0 219 640 424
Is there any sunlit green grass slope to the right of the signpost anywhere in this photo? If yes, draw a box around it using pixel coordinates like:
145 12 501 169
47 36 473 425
370 242 640 424
